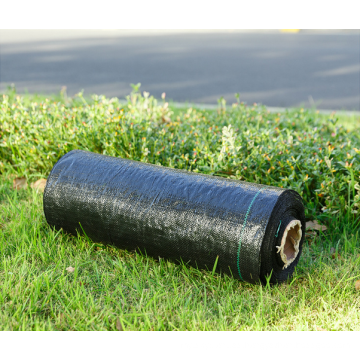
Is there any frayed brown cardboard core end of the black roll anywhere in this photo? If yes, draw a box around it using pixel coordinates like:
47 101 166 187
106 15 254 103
277 220 302 269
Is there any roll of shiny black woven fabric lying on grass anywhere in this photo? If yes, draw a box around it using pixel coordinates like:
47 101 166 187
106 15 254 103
44 150 305 283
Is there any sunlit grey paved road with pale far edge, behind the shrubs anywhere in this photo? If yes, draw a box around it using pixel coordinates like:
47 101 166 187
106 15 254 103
0 30 360 111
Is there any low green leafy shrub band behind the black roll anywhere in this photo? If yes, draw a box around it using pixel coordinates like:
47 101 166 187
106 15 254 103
0 86 360 219
